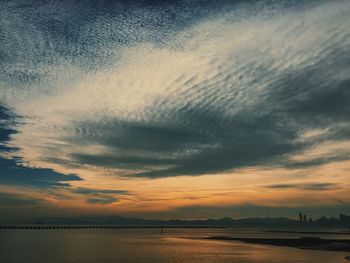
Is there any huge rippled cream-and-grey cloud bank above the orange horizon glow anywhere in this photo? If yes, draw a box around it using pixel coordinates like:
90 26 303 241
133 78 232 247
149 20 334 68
0 1 350 182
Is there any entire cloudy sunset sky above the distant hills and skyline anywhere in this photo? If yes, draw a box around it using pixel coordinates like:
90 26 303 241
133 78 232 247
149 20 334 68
0 0 350 222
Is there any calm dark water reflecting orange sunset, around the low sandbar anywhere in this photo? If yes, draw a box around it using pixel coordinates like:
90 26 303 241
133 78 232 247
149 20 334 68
0 229 349 263
